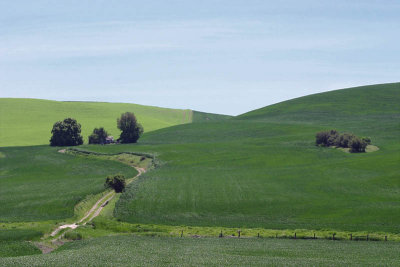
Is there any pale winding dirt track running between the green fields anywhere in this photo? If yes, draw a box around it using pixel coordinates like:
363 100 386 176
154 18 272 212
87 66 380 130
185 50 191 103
50 166 146 237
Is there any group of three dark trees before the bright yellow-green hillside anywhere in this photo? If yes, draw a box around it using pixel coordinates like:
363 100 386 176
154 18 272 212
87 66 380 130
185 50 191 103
50 112 143 146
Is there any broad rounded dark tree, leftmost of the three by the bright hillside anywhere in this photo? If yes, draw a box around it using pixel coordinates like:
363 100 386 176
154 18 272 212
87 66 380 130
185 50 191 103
50 118 83 146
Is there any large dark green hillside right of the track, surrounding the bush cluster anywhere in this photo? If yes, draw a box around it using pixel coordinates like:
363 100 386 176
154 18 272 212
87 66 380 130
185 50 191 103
82 84 400 233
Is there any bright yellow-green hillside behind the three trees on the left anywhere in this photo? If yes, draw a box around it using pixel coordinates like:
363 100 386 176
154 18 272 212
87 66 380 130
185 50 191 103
0 98 193 146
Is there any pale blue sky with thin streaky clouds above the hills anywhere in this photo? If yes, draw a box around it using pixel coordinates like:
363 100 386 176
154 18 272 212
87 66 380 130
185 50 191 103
0 0 400 115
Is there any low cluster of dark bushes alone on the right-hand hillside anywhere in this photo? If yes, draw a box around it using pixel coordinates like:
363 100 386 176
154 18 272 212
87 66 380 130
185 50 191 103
315 130 371 153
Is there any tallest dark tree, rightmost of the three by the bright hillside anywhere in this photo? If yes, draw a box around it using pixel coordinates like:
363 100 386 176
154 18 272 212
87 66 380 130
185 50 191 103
117 112 143 143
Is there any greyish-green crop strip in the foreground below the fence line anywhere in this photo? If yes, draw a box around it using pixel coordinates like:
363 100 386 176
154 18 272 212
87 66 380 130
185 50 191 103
0 236 400 266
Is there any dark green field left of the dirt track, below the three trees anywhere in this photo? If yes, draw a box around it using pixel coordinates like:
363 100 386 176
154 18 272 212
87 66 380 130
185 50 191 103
0 146 137 222
